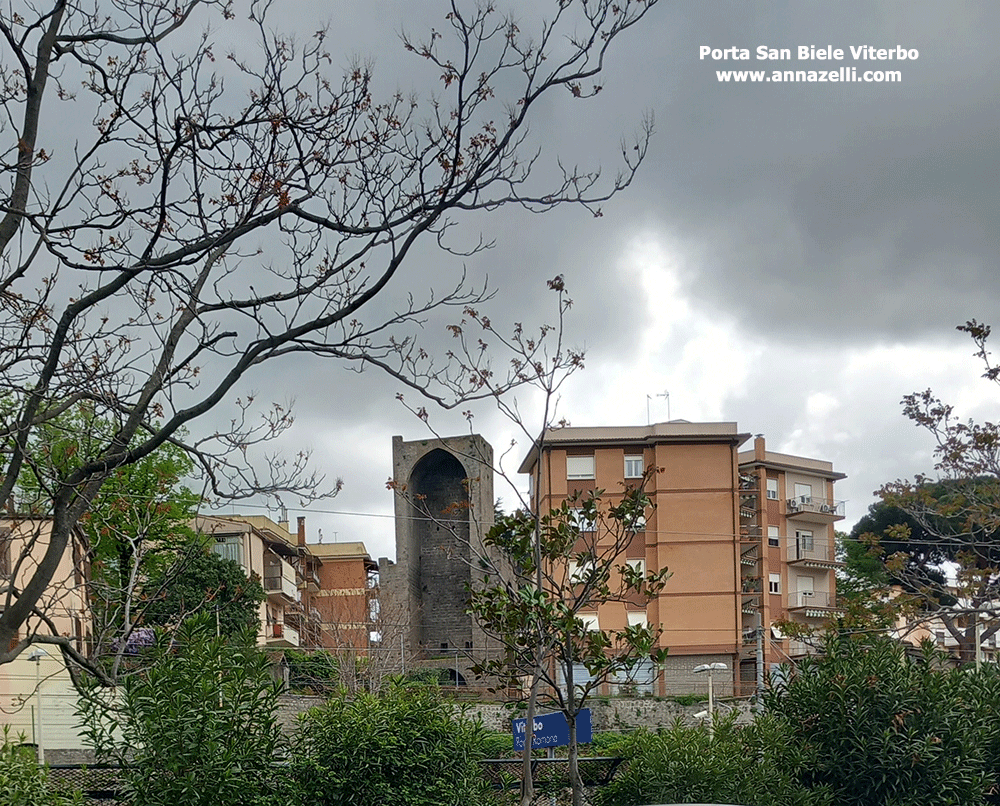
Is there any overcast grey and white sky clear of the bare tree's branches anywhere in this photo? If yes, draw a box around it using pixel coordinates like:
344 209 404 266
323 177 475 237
203 0 1000 568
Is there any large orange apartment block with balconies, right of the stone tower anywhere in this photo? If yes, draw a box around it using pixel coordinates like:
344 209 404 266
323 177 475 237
520 420 844 694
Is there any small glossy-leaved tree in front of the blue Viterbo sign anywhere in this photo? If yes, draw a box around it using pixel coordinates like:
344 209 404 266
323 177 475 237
469 487 669 806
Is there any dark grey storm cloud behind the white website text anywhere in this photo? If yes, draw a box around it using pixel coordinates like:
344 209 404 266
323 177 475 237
512 3 1000 340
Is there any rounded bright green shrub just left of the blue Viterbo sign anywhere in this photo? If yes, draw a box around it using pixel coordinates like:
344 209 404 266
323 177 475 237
293 682 485 806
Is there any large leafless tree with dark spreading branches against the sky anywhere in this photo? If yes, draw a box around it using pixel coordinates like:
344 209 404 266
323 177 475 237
0 0 655 662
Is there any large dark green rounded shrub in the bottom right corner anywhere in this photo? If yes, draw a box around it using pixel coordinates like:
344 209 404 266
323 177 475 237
766 636 998 806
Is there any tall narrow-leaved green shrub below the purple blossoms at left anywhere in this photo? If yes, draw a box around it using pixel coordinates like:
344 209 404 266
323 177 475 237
81 616 291 806
